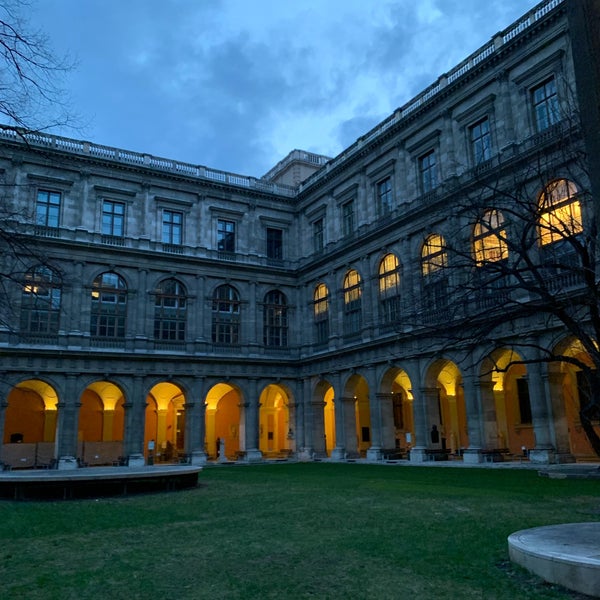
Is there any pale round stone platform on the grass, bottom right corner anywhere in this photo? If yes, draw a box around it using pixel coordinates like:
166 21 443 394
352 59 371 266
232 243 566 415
508 523 600 598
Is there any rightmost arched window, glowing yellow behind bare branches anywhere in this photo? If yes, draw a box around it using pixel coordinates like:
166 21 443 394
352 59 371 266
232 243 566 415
538 179 583 246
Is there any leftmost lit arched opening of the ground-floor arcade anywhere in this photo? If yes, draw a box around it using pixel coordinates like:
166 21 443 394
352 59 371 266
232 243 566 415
2 379 58 468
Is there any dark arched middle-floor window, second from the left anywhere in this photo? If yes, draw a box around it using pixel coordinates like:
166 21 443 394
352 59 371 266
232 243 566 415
90 271 127 338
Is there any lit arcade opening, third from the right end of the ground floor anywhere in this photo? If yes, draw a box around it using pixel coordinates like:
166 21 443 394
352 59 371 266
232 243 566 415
425 360 469 454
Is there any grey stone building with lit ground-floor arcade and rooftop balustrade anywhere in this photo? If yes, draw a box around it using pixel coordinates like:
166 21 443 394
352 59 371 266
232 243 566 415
0 0 592 468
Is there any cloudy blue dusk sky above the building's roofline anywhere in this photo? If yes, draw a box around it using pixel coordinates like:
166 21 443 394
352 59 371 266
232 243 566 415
27 0 537 177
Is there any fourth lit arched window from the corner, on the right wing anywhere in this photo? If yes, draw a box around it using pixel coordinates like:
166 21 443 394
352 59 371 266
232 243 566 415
421 233 448 318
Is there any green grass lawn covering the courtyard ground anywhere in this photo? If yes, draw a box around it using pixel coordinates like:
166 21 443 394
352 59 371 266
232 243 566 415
0 463 600 600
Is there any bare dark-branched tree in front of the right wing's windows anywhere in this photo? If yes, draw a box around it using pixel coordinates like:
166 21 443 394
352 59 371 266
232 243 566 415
420 118 600 456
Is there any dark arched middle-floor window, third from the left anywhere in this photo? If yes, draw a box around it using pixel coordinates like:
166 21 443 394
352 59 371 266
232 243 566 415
154 279 187 342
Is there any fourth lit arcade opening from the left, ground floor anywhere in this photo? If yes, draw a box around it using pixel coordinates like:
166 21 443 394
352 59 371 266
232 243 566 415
206 383 240 460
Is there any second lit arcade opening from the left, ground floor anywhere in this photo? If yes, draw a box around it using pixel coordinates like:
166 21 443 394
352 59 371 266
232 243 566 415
77 381 125 465
